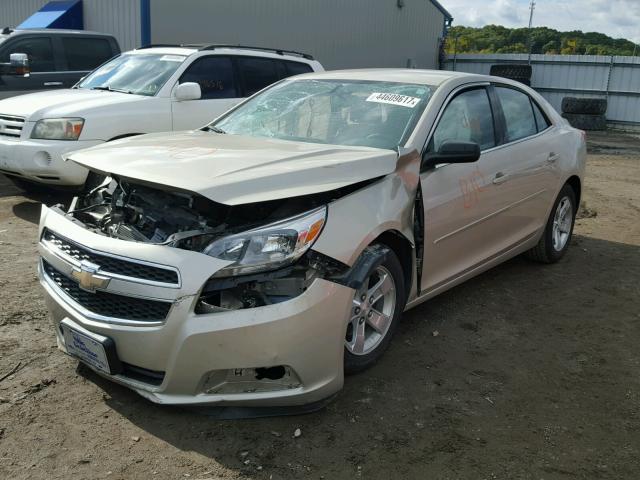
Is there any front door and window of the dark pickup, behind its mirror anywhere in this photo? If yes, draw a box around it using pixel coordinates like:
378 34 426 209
0 35 61 99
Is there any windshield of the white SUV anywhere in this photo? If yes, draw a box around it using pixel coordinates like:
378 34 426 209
77 54 186 96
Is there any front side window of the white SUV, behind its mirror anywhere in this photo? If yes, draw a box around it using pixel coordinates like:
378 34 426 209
180 56 239 100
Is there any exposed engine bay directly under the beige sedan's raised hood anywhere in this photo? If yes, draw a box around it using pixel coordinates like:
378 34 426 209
67 177 327 251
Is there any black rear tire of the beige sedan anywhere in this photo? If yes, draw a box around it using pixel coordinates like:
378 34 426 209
525 184 578 263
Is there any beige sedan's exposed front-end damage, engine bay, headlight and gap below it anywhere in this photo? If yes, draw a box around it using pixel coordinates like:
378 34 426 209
65 172 372 308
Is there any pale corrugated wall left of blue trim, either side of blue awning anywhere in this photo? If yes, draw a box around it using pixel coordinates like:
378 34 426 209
0 0 140 50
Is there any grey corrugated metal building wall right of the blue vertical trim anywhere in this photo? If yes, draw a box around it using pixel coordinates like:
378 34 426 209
151 0 444 69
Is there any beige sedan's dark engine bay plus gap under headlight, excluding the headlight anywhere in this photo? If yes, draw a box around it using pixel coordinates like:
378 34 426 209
66 172 368 314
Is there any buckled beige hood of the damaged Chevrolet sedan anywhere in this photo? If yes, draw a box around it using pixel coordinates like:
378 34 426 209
68 131 398 205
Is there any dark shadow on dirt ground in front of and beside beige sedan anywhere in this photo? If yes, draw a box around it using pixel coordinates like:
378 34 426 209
79 236 640 479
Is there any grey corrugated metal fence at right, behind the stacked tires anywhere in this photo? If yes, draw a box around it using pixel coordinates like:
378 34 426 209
445 54 640 127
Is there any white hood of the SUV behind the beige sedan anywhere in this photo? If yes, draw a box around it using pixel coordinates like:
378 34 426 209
0 88 152 122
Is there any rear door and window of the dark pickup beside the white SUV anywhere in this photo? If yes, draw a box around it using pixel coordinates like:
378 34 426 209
58 35 118 88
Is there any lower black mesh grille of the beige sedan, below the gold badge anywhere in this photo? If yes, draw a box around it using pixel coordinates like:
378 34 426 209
42 260 171 322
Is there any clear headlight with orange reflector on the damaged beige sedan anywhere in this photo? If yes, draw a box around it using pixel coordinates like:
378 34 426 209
204 207 327 277
